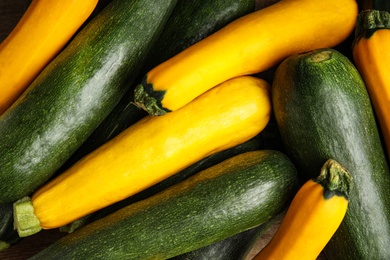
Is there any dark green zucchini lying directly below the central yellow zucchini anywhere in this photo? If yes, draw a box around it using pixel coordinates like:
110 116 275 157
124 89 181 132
32 150 298 260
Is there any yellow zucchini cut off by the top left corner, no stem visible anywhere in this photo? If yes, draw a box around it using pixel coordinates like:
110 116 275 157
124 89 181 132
0 0 98 115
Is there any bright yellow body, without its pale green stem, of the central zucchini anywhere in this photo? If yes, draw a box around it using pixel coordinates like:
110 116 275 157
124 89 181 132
32 76 271 229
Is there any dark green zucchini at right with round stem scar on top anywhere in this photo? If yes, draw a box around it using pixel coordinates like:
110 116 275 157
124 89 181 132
272 49 390 260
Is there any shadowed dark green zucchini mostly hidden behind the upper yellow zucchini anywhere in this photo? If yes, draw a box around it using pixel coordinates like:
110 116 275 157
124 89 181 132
64 0 256 170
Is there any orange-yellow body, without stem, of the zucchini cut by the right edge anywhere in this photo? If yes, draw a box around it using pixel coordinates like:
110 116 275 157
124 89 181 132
353 29 390 160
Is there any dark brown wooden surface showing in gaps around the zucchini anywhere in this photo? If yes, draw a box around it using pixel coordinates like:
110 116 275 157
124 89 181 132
0 0 325 260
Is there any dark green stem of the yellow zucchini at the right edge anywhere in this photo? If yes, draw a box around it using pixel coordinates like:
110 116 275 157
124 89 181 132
355 10 390 39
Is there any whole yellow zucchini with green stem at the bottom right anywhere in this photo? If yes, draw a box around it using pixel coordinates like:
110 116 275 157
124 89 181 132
254 159 353 260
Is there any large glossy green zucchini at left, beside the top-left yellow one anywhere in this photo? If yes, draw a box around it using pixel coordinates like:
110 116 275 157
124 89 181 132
0 0 176 202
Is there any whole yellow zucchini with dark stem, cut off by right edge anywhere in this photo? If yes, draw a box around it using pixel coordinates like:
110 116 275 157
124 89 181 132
353 10 390 156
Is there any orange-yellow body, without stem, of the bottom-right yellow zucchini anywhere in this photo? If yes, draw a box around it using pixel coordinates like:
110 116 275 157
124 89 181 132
253 180 348 260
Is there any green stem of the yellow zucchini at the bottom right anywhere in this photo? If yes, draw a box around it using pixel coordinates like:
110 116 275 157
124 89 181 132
313 159 353 200
